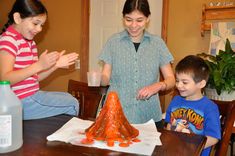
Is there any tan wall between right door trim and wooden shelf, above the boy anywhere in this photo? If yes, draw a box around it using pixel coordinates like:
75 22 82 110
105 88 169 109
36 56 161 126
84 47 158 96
165 0 234 106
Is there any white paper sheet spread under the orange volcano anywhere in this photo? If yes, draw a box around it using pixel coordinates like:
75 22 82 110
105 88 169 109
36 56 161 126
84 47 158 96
47 117 162 155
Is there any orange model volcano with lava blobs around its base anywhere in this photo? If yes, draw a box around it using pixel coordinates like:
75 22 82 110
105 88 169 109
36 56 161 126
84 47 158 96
82 92 140 147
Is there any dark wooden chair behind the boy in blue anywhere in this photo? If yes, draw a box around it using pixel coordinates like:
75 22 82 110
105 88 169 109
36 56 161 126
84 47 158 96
211 100 235 156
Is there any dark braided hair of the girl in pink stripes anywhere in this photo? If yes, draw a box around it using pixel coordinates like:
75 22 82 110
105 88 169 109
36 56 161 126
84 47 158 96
1 0 47 33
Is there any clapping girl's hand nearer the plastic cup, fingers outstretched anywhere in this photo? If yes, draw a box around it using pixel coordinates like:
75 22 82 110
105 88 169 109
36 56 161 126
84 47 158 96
55 50 78 68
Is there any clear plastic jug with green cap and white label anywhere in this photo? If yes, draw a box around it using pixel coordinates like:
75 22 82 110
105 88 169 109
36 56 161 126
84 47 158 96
0 81 23 153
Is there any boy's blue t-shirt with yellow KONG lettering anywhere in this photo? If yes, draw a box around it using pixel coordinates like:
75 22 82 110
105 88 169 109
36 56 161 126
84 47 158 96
165 96 221 156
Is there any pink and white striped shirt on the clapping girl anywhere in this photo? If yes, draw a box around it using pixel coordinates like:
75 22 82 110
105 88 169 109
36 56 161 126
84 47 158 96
0 26 39 99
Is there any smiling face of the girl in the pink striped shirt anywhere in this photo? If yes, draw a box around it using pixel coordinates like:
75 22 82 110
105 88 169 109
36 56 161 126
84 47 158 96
14 14 47 40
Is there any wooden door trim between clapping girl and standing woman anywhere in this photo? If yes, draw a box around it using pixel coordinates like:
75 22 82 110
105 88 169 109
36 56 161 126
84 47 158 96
80 0 90 82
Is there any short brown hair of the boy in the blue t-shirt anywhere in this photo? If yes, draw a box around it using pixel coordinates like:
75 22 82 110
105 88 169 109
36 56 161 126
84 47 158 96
175 55 209 83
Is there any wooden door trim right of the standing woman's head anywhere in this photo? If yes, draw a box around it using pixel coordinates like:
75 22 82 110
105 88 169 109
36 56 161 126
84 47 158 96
161 0 169 43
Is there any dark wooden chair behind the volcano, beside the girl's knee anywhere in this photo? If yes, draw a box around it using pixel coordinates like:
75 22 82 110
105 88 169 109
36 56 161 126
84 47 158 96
68 80 108 119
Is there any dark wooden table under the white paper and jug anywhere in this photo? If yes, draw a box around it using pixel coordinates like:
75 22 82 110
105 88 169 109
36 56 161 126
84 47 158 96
1 115 206 156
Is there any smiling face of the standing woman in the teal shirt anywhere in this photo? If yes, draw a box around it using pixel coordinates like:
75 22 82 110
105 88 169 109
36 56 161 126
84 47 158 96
123 10 149 43
